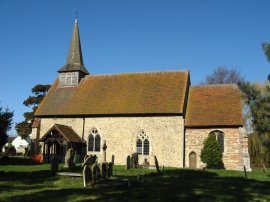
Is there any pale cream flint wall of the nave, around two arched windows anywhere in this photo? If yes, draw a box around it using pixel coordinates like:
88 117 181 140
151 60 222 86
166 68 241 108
40 116 184 167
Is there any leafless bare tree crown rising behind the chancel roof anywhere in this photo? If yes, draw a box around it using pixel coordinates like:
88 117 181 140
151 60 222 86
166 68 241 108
202 66 245 84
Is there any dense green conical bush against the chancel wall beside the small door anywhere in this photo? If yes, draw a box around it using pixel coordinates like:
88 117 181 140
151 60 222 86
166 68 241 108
201 136 224 169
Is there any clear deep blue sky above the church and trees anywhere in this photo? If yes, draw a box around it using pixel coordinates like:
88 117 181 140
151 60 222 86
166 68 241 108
0 0 270 134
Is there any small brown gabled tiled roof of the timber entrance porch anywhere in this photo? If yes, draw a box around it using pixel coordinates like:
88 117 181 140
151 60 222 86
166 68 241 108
39 124 85 143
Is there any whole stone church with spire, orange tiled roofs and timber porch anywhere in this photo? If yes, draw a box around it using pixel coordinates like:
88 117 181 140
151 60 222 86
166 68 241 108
32 19 250 170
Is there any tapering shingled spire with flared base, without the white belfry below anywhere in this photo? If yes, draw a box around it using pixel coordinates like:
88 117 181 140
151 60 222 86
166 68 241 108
58 17 89 74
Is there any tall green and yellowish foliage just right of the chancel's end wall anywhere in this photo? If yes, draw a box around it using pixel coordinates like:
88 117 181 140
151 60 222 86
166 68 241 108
239 82 270 167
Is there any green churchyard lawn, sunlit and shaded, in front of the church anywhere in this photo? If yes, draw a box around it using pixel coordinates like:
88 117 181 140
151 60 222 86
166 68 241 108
0 159 270 202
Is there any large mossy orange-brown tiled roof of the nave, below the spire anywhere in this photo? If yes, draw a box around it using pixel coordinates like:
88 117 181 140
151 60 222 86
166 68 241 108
35 71 189 116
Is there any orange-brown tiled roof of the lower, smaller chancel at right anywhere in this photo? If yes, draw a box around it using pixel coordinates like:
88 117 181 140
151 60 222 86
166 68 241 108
185 85 242 127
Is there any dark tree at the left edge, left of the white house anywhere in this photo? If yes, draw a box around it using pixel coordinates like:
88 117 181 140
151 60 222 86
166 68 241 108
0 107 13 151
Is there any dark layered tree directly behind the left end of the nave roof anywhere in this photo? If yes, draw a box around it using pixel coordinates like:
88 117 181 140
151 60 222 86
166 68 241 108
15 84 51 138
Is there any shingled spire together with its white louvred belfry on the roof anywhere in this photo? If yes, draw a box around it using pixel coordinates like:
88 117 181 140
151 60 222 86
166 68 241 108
58 18 89 86
